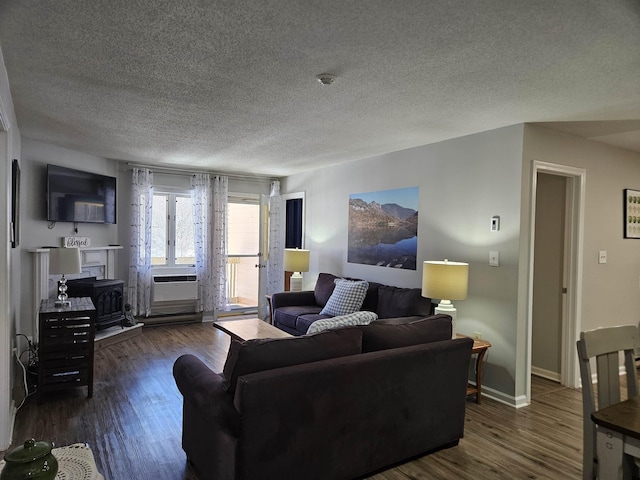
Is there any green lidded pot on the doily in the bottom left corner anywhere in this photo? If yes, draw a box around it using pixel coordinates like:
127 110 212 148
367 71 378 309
0 438 58 480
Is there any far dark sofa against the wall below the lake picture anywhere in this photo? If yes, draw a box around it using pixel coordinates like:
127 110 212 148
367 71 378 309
271 273 434 335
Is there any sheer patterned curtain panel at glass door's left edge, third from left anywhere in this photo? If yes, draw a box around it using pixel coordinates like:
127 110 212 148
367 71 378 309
211 175 231 312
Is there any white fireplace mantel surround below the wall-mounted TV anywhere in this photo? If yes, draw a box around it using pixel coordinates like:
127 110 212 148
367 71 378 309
31 245 122 332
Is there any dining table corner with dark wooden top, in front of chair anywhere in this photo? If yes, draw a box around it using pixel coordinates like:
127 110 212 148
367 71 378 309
591 396 640 480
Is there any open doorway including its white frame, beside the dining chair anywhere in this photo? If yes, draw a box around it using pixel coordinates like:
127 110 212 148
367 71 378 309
521 161 586 404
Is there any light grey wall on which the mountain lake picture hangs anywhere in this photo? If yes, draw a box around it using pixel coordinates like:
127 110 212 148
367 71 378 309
282 125 523 402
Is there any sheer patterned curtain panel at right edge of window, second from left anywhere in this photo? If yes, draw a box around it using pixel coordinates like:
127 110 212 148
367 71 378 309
191 173 215 312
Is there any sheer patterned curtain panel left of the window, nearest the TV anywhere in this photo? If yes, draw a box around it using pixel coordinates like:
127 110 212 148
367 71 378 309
127 168 153 317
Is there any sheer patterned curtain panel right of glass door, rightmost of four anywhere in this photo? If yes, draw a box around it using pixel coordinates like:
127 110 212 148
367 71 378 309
267 180 284 295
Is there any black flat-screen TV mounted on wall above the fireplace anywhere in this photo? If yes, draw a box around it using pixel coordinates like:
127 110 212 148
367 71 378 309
47 164 116 223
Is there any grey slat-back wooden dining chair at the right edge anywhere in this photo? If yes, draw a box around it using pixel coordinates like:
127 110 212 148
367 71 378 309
577 325 640 480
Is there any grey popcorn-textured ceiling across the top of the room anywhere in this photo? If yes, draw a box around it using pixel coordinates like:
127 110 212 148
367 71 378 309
0 0 640 175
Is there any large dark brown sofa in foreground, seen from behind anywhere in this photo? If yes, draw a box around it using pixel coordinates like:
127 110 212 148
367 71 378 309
174 316 473 480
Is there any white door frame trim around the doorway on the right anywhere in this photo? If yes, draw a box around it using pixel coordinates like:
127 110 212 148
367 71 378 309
525 160 587 403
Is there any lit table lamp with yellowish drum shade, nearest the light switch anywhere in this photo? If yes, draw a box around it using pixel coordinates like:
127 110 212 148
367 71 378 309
422 259 469 338
